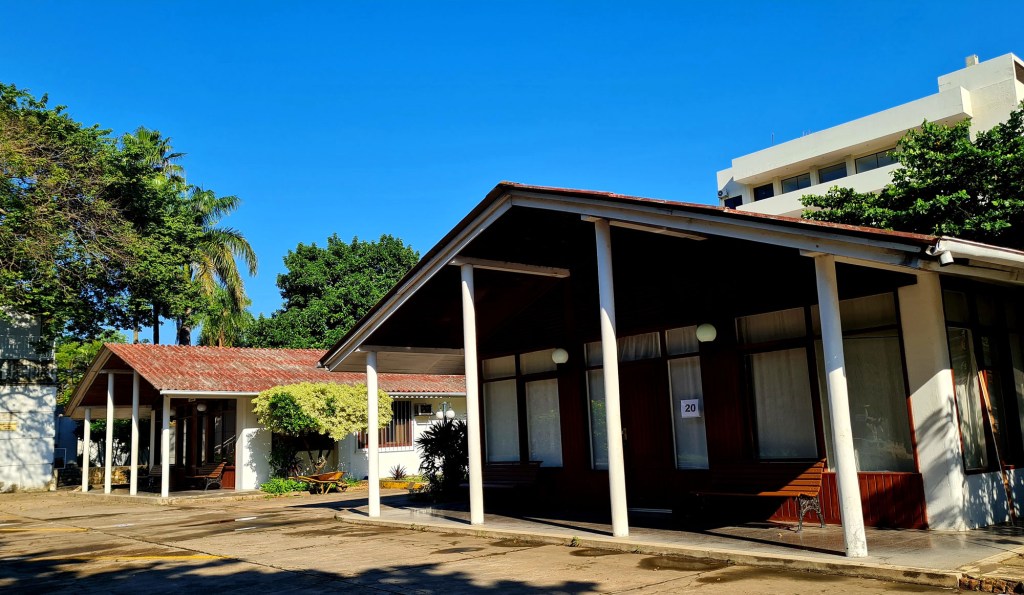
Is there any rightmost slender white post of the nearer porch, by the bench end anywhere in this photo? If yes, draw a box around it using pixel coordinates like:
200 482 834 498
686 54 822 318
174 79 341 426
814 254 867 558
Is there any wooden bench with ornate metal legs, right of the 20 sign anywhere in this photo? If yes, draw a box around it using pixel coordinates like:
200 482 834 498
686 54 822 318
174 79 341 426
693 460 825 532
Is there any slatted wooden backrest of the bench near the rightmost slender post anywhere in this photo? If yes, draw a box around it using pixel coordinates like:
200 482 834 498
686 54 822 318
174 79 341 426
712 460 825 497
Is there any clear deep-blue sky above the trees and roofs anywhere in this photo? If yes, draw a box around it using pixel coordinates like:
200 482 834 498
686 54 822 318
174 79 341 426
0 0 1024 337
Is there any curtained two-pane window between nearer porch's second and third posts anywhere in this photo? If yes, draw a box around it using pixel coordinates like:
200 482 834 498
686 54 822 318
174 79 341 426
483 349 562 467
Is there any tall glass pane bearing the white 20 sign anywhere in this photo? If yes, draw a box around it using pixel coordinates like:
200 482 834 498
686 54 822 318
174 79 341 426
669 357 708 469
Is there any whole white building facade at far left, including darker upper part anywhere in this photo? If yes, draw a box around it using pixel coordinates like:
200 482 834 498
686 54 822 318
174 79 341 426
0 314 57 492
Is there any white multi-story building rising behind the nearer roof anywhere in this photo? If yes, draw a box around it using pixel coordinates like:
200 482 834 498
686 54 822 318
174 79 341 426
718 53 1024 216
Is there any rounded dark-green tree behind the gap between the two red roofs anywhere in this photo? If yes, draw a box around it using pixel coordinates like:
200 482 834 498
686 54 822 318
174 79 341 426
245 236 420 349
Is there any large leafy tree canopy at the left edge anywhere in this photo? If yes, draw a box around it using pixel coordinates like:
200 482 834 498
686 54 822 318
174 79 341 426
0 83 256 342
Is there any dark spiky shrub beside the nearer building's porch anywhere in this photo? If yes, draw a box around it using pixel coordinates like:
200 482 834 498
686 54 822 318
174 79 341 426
416 419 469 500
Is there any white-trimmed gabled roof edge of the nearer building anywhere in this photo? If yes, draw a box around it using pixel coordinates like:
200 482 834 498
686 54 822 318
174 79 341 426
321 182 1024 373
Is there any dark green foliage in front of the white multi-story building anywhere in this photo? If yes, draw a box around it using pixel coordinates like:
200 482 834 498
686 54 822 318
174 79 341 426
802 103 1024 249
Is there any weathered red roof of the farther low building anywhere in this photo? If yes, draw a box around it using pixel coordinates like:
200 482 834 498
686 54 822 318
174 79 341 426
105 343 466 394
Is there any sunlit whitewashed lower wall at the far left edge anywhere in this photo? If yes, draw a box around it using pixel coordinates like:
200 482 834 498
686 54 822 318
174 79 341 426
0 385 56 492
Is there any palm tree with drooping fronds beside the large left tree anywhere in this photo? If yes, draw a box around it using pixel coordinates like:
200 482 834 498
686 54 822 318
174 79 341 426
177 186 257 345
